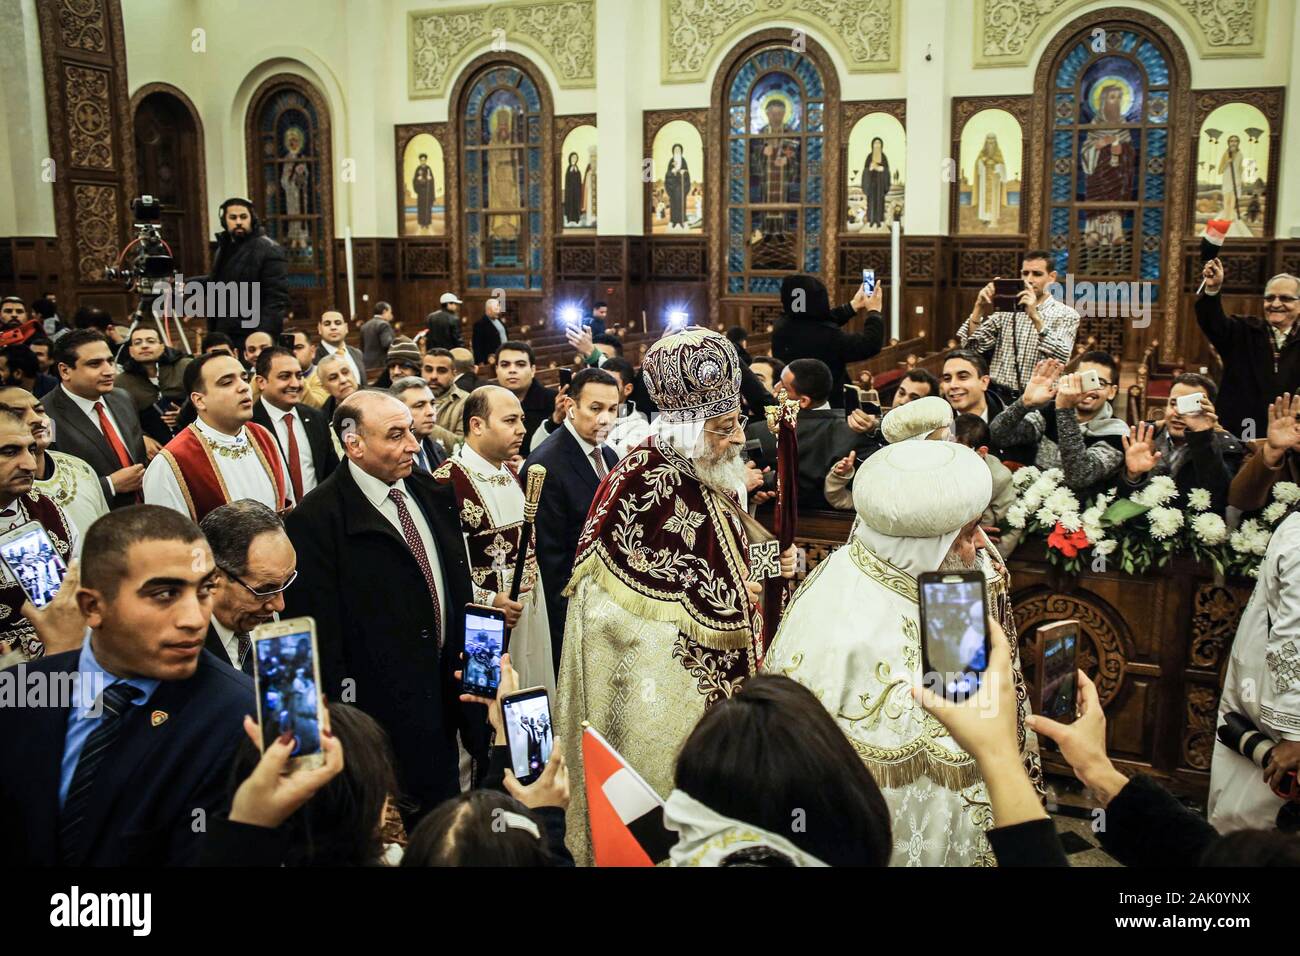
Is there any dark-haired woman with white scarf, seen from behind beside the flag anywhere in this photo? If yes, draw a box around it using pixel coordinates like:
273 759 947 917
664 675 892 866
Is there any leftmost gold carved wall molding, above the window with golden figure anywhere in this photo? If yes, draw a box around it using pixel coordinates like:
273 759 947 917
407 0 595 99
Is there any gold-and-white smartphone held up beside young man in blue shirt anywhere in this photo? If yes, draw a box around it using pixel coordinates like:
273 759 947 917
252 618 325 770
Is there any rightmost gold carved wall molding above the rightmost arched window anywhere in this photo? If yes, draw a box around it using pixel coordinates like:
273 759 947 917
974 0 1268 66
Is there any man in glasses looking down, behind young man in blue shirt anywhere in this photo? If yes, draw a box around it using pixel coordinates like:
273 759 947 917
199 498 298 675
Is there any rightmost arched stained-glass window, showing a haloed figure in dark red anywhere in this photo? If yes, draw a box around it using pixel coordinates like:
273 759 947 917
1047 25 1173 289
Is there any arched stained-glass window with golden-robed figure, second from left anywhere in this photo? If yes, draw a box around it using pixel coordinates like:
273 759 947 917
460 64 545 291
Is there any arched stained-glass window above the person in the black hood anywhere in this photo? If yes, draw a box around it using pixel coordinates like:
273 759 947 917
723 42 833 295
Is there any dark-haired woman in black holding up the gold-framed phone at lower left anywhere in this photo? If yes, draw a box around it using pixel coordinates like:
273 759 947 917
200 704 398 866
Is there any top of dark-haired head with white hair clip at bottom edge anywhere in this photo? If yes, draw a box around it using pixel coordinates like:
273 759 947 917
402 790 572 866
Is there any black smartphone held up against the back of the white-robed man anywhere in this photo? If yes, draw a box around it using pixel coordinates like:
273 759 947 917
918 571 989 700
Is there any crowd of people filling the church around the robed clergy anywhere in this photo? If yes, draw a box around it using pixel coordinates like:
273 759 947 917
0 199 1300 866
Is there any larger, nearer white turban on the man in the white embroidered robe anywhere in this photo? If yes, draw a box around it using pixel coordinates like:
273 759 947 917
853 439 993 576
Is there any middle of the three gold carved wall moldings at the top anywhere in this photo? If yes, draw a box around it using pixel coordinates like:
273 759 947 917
659 0 902 83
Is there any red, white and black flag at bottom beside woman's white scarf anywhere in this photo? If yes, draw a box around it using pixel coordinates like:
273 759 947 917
582 726 677 866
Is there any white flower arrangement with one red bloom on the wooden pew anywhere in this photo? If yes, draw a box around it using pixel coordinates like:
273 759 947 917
1006 466 1300 578
